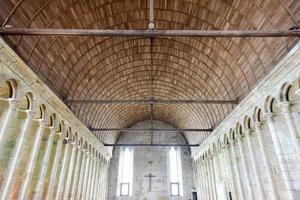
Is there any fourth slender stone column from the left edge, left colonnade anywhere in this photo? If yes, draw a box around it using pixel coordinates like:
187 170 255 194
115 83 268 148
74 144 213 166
33 126 56 200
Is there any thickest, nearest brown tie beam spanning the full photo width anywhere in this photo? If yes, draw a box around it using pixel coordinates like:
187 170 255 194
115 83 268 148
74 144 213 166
0 27 300 37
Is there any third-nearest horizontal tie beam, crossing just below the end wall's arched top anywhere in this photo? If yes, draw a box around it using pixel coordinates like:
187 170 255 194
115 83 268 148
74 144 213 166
90 128 213 132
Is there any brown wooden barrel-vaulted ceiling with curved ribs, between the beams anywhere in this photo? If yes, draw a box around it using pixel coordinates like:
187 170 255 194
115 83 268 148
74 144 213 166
0 0 300 143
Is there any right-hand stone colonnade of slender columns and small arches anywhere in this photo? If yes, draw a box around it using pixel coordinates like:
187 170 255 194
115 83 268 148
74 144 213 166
193 74 300 200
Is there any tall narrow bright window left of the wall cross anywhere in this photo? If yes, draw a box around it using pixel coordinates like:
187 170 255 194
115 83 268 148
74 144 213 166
117 147 133 196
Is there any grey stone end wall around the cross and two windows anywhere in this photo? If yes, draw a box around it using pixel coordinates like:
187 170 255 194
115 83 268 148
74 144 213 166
109 121 194 200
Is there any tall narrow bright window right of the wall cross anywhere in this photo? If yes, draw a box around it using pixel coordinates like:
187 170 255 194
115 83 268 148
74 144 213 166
169 147 183 196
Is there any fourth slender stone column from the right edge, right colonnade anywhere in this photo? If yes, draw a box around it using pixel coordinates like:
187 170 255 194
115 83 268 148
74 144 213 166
245 129 265 200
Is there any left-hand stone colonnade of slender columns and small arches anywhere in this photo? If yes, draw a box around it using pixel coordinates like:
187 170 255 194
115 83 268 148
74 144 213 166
0 76 110 200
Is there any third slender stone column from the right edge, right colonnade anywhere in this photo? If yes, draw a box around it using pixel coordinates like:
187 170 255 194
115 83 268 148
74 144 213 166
255 122 279 200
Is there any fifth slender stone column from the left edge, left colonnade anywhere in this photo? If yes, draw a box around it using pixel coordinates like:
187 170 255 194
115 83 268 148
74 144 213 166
46 133 63 200
